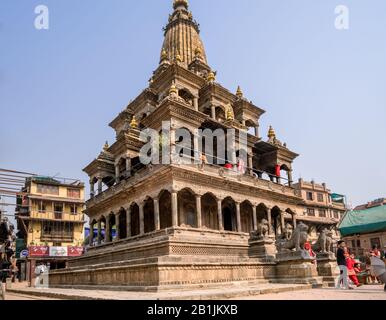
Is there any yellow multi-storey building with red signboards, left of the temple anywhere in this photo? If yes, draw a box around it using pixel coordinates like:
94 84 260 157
16 176 84 280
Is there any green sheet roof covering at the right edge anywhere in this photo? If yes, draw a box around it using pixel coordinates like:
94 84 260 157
339 206 386 237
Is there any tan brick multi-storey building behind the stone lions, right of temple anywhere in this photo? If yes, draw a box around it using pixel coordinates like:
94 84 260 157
293 179 347 240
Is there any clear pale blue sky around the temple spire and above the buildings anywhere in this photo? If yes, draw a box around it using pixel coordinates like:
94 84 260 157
0 0 386 209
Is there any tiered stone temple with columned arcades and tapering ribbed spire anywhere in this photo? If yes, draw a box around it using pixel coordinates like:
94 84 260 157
50 0 336 291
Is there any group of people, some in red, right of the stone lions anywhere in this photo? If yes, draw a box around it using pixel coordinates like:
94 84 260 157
336 241 386 292
